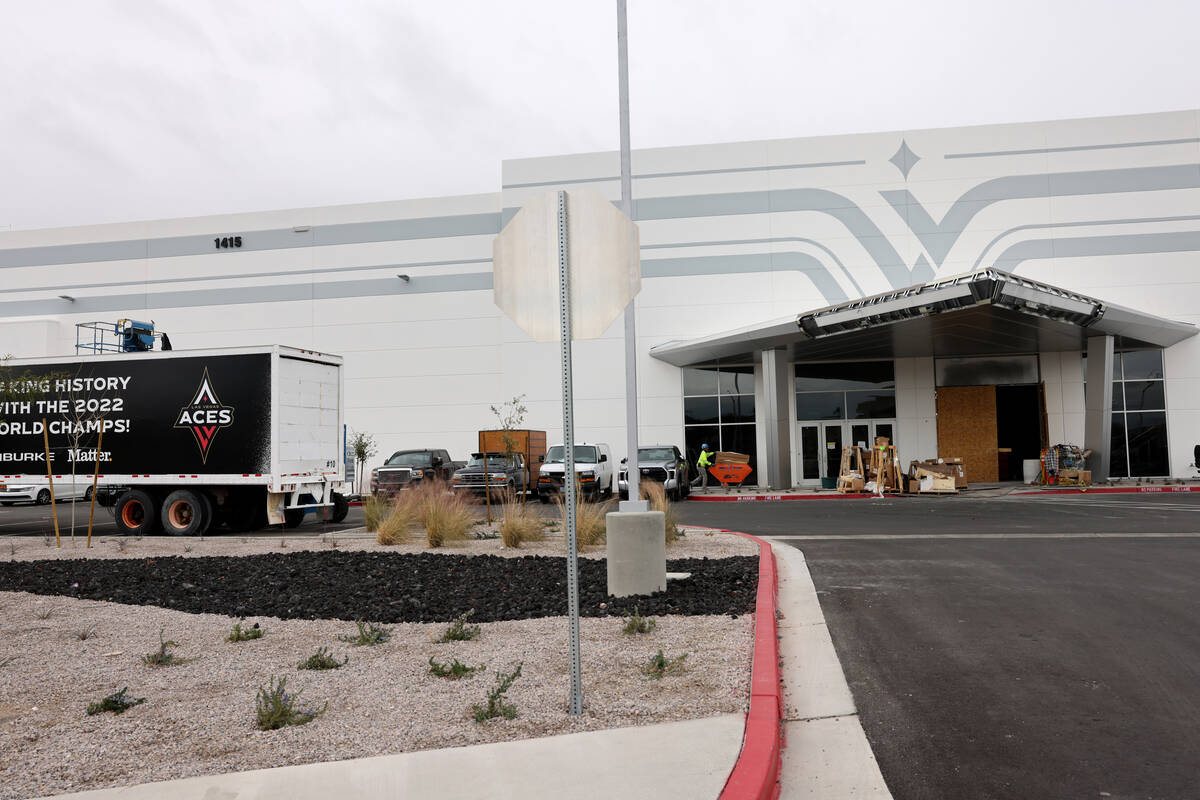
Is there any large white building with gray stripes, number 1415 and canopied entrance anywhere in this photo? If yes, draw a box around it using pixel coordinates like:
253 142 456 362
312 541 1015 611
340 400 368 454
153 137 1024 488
0 110 1200 488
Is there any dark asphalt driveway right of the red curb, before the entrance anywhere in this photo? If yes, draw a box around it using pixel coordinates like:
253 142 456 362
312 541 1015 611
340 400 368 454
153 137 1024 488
683 494 1200 800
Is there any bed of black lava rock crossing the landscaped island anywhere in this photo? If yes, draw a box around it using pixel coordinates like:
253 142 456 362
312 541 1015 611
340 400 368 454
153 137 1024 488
0 551 758 622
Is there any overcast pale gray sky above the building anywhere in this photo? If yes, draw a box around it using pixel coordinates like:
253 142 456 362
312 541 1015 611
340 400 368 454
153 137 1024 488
0 0 1200 229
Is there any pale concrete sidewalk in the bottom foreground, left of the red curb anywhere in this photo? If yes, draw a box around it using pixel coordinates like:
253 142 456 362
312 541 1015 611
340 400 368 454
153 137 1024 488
39 714 745 800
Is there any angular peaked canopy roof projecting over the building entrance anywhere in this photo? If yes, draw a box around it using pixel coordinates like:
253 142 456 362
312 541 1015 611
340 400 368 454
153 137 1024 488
650 270 1196 367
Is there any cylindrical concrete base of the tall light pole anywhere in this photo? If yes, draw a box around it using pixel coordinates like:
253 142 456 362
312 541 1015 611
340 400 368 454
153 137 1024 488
606 511 667 597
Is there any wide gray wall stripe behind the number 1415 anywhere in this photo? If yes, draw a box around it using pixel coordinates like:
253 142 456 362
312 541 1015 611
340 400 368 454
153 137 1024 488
0 212 500 269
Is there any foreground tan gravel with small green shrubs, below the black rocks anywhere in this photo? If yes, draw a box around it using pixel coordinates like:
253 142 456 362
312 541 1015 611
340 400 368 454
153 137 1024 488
0 591 752 799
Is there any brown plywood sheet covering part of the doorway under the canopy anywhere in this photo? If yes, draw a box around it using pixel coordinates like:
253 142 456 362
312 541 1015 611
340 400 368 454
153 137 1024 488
937 386 1000 483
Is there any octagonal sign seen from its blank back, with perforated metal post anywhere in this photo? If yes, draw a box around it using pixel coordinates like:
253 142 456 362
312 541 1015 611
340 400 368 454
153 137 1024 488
492 190 642 716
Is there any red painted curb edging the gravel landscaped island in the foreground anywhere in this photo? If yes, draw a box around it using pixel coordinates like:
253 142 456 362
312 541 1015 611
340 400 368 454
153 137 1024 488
721 530 784 800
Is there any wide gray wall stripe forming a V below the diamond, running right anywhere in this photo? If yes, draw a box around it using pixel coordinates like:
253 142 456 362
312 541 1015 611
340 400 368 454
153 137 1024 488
888 164 1200 267
